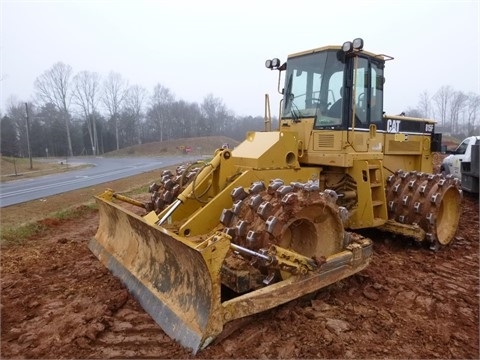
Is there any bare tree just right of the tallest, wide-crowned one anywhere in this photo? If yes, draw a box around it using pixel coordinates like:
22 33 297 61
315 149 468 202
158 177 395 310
73 71 100 155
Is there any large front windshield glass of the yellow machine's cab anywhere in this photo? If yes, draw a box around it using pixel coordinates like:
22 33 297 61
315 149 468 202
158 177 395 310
282 50 344 127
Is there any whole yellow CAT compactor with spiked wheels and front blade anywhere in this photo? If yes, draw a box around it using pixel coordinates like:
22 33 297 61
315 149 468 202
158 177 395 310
90 39 462 353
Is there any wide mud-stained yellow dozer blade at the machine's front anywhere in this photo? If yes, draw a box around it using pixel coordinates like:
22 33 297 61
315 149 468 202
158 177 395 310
89 197 230 353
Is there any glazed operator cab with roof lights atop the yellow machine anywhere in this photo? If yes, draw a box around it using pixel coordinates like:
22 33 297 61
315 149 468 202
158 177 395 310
266 39 385 130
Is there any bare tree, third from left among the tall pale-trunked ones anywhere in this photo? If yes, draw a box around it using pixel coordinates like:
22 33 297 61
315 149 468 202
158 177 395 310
102 71 128 150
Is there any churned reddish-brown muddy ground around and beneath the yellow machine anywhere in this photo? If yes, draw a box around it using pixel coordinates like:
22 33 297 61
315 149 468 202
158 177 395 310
1 188 479 359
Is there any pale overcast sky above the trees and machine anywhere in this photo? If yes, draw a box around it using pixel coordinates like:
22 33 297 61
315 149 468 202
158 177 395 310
0 0 480 116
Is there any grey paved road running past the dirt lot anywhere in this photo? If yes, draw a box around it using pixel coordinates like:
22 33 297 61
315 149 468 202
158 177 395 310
0 156 198 207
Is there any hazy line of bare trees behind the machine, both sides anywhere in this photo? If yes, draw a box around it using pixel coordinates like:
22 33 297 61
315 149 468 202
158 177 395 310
0 62 480 157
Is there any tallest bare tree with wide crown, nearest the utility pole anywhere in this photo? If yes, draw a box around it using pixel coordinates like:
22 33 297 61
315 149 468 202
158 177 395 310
34 62 73 156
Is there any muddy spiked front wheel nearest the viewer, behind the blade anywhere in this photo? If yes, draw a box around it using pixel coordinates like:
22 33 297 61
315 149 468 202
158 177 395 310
221 179 344 260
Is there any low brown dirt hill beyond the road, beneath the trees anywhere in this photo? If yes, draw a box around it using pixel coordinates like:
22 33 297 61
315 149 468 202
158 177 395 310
104 136 239 156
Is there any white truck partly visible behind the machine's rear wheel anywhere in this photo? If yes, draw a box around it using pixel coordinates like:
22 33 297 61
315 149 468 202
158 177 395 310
440 136 480 193
